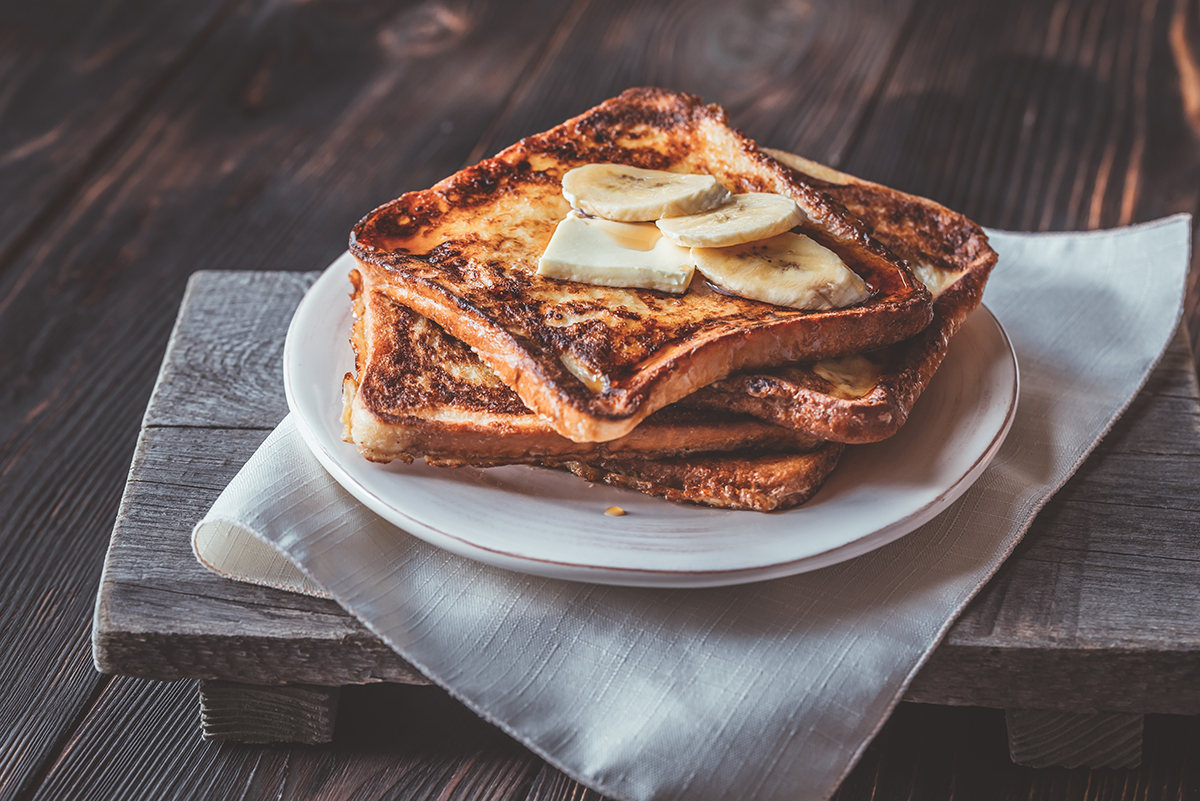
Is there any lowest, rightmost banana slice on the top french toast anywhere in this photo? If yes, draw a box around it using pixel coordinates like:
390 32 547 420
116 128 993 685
691 233 870 312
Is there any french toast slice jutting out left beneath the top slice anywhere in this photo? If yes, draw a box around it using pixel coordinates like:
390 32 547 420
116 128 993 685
342 271 820 466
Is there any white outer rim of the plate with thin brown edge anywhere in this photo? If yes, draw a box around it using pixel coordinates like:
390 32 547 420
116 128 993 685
283 252 1020 588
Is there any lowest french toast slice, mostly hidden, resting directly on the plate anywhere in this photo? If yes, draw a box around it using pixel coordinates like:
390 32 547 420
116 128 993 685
558 442 845 512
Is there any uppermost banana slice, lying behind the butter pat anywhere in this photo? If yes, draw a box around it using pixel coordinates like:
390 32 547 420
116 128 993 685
563 164 730 222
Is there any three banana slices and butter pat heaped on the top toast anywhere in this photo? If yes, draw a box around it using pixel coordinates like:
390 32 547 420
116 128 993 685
549 164 870 311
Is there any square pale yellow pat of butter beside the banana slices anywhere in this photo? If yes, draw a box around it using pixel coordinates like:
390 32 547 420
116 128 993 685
538 210 696 294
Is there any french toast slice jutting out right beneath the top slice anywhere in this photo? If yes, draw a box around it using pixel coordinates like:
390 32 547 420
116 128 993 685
680 150 996 442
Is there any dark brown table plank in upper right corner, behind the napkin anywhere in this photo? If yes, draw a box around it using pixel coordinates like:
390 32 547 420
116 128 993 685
844 0 1200 369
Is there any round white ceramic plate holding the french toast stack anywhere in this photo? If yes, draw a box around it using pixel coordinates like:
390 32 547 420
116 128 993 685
283 254 1018 586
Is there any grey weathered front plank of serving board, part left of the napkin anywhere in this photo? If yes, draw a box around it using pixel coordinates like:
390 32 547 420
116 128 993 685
94 428 426 685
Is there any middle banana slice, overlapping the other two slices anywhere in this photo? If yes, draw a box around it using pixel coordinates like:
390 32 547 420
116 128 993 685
655 192 804 247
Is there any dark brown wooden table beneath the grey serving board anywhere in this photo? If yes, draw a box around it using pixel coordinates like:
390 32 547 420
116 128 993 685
0 0 1200 799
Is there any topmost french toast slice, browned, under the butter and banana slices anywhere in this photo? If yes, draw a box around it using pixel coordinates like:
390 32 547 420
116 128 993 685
350 89 932 442
